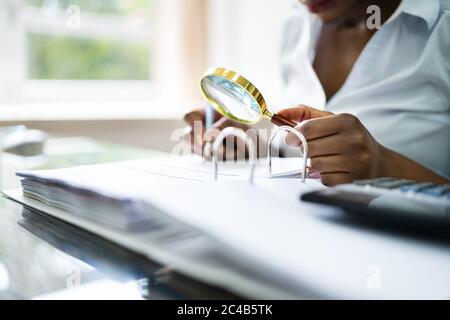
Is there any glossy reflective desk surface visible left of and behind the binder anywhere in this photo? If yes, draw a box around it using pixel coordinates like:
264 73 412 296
0 139 237 299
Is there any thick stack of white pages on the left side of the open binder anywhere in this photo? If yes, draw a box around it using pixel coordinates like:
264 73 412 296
17 157 306 231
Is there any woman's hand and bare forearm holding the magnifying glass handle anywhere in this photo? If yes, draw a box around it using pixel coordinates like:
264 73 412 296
278 106 449 186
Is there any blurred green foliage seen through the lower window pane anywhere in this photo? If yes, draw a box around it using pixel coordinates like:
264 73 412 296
28 34 150 80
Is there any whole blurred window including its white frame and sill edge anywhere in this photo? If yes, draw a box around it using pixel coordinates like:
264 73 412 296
0 0 158 101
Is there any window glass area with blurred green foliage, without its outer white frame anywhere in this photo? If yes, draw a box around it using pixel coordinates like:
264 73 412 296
24 0 153 80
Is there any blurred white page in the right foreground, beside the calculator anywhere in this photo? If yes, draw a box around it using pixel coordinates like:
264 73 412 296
135 179 450 299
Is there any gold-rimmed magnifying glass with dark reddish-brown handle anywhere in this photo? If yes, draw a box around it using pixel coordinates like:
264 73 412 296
200 68 297 127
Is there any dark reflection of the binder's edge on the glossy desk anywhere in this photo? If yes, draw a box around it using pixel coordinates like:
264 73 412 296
18 207 236 299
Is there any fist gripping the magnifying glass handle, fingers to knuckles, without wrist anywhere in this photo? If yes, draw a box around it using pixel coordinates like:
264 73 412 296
280 107 374 186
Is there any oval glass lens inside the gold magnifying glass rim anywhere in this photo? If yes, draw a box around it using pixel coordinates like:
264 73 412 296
201 75 261 123
